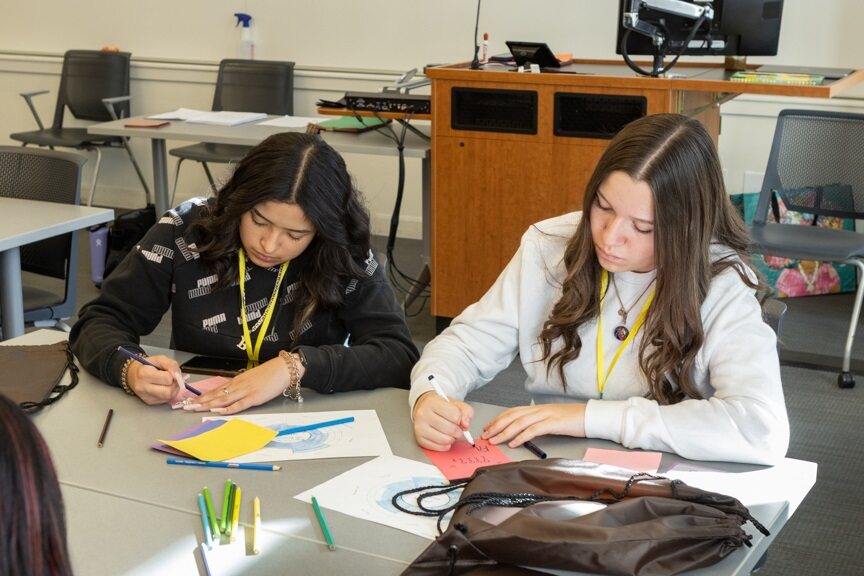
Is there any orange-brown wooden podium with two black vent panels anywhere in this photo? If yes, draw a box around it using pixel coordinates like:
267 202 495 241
426 60 864 326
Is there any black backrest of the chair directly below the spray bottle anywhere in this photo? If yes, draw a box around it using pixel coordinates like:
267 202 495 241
213 59 294 115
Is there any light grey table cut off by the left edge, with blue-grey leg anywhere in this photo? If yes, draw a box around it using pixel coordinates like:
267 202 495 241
0 198 114 338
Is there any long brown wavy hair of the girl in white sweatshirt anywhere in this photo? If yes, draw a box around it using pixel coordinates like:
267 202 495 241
540 114 760 404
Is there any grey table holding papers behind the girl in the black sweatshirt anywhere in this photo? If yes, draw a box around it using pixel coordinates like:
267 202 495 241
87 116 430 214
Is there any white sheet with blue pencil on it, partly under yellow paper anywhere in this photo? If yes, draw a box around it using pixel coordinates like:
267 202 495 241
203 410 393 463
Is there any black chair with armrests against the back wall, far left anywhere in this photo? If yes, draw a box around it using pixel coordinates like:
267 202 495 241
9 50 150 205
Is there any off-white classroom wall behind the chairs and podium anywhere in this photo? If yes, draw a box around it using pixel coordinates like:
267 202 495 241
0 0 864 238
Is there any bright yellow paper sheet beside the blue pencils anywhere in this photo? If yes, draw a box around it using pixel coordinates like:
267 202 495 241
159 418 276 462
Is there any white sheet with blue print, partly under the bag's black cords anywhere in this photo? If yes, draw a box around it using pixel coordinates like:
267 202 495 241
295 456 462 540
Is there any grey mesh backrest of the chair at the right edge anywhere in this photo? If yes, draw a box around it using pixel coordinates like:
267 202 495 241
753 110 864 225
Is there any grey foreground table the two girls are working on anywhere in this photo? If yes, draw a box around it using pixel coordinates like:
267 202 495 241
14 331 816 576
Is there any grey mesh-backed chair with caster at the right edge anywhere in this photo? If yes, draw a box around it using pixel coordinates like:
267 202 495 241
750 110 864 388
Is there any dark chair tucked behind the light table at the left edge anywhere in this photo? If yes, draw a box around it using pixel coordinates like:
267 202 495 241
0 146 87 332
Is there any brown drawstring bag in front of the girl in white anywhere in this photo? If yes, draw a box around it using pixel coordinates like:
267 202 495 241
393 458 768 576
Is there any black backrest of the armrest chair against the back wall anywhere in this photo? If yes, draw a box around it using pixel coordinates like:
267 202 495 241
53 50 131 128
